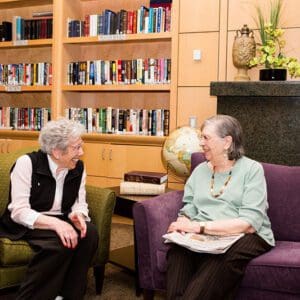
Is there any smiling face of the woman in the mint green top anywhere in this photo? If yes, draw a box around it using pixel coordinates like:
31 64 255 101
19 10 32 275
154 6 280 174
200 124 231 161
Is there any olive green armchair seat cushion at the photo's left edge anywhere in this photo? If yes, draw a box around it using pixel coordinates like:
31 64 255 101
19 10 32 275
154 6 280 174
0 238 34 267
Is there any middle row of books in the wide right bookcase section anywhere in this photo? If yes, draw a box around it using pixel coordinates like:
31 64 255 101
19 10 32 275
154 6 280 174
67 58 171 85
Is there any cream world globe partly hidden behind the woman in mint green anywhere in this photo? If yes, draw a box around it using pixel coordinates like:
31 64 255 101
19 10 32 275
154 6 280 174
163 126 201 177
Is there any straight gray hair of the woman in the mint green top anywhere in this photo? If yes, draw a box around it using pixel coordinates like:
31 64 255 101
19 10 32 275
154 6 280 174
201 115 245 160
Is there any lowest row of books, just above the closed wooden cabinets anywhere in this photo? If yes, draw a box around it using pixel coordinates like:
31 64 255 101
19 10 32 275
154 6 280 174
65 107 170 136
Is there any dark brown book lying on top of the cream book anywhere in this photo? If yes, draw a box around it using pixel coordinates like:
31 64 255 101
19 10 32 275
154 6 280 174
124 171 168 184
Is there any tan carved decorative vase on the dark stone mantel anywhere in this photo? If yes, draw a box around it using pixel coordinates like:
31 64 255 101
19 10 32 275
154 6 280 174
232 25 256 81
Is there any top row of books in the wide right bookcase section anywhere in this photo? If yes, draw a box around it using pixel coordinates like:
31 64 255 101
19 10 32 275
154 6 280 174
68 6 171 37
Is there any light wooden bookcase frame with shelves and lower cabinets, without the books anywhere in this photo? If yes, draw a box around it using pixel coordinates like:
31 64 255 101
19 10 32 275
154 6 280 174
0 0 179 186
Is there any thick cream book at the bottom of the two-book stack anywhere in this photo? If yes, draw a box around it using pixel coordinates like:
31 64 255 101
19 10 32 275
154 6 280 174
120 181 166 195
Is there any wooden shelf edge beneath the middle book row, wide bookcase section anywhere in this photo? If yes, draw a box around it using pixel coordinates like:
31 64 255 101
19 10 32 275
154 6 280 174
62 84 170 92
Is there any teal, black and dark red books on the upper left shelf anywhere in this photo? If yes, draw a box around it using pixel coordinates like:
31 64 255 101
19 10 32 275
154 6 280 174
12 16 53 41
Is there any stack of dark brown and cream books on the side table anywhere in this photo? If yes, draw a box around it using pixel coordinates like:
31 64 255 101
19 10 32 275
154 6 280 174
120 171 168 195
